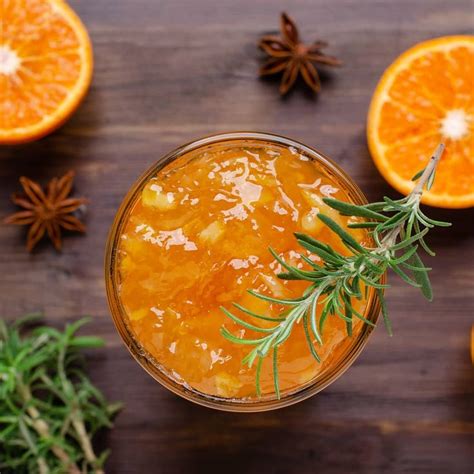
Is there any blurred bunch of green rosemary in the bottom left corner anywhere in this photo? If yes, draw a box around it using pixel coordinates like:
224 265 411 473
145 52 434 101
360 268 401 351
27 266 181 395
0 315 120 474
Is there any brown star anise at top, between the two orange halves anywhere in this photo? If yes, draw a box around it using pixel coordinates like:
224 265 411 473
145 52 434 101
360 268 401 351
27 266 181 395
258 12 341 95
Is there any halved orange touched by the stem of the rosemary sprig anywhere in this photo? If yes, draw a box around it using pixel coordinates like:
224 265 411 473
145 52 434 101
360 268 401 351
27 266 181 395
367 36 474 208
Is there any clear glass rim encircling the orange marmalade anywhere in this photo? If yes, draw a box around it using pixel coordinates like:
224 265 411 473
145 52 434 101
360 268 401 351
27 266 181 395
104 131 385 412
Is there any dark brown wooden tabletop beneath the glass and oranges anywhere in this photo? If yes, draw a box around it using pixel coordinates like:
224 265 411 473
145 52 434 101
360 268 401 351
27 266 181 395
0 0 474 474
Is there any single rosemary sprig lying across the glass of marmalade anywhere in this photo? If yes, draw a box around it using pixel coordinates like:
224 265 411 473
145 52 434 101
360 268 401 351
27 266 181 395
221 144 451 398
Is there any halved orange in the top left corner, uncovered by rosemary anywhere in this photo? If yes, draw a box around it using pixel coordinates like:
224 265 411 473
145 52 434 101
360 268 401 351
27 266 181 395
0 0 92 144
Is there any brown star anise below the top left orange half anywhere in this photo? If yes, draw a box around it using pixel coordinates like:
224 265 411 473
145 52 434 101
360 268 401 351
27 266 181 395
4 171 87 252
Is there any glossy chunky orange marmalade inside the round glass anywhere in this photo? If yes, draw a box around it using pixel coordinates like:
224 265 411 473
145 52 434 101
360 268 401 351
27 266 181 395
117 140 366 398
